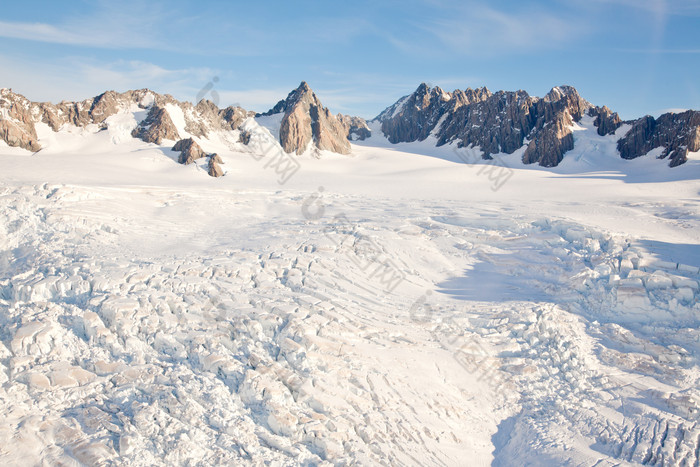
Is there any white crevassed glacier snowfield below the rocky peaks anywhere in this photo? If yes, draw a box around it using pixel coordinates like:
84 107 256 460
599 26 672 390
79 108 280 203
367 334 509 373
0 115 700 466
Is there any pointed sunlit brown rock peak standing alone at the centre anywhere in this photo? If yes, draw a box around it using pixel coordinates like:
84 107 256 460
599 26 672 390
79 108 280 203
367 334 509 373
262 82 350 154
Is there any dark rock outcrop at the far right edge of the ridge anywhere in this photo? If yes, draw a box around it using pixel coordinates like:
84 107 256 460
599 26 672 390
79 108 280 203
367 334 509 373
617 110 700 167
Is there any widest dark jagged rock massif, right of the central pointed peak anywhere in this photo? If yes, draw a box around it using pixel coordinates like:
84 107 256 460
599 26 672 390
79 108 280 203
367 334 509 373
376 83 591 167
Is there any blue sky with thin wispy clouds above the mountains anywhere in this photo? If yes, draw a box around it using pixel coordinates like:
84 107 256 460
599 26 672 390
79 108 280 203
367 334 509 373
0 0 700 119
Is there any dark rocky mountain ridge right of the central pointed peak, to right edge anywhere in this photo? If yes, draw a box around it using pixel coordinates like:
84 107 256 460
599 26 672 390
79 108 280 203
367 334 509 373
373 83 700 167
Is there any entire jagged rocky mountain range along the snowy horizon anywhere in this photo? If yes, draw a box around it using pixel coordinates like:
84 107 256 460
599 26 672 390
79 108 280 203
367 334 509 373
0 82 700 176
